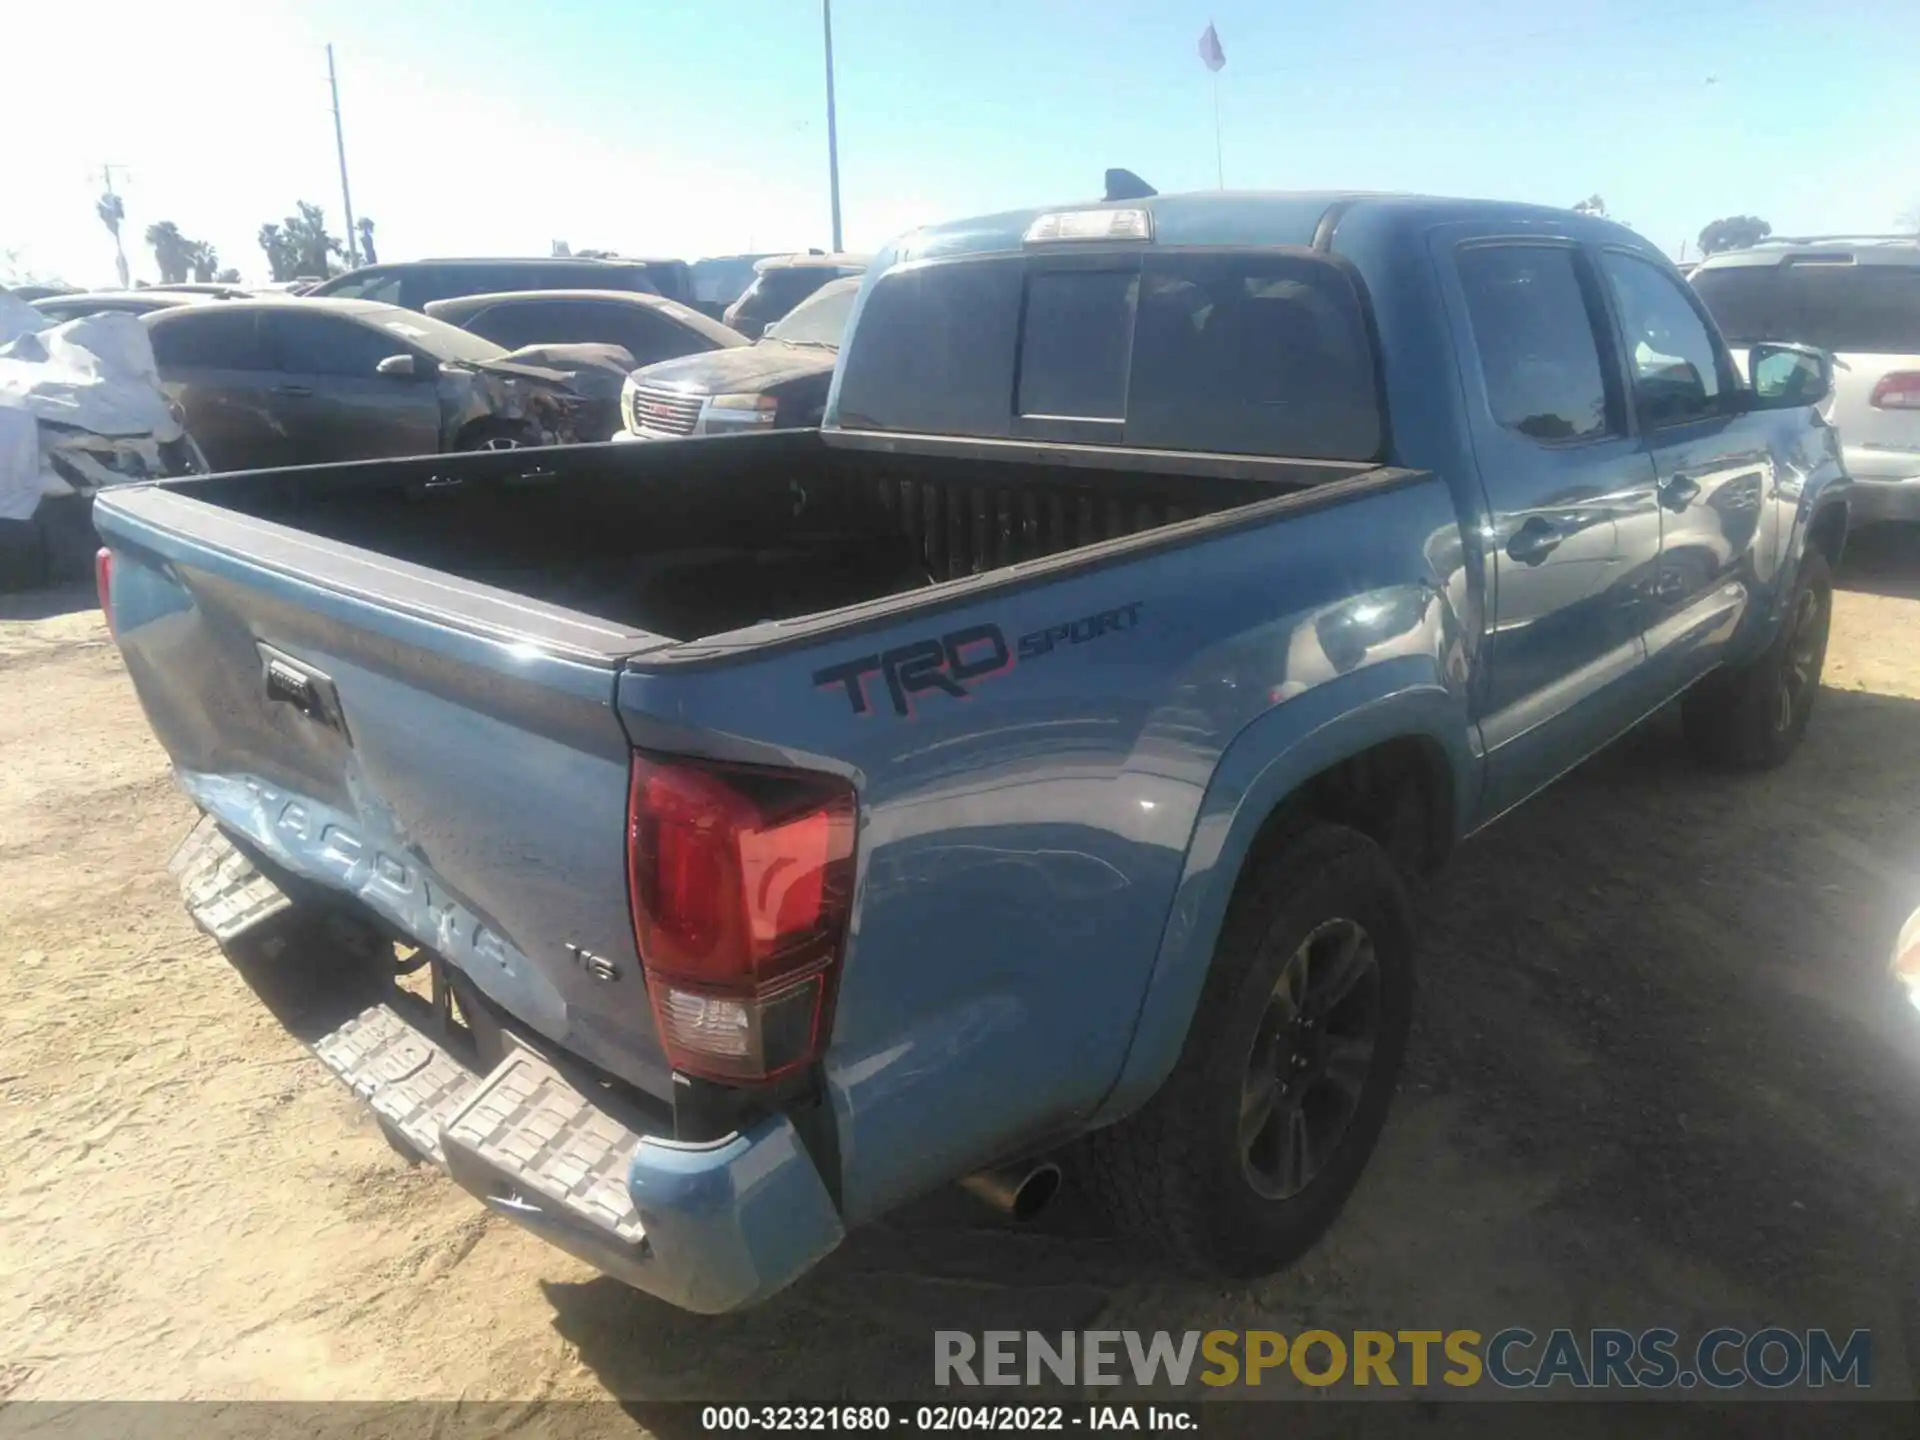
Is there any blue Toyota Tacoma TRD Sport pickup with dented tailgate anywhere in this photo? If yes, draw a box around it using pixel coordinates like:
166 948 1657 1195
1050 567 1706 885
96 194 1847 1311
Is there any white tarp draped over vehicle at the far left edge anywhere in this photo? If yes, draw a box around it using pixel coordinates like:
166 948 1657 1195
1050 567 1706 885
0 296 180 520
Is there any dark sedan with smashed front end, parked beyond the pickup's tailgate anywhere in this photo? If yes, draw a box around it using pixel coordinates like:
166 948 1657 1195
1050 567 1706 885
144 300 605 470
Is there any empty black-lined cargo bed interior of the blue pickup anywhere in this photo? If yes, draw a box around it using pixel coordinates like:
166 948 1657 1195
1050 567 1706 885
169 430 1367 641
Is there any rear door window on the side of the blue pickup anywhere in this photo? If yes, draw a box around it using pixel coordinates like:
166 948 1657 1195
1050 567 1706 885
1459 246 1624 444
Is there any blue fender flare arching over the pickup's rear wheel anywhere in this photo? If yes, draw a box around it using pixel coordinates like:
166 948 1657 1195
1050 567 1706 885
1092 657 1480 1127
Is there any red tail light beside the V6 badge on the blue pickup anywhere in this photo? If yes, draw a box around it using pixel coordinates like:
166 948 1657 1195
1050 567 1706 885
626 755 856 1081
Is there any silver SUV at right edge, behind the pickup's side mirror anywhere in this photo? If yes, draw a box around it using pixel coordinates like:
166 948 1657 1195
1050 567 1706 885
1688 236 1920 524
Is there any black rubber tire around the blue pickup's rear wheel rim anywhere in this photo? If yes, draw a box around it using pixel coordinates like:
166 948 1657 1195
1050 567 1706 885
1083 826 1413 1277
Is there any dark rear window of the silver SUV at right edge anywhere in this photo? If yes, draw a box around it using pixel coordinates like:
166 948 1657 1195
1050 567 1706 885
1693 255 1920 355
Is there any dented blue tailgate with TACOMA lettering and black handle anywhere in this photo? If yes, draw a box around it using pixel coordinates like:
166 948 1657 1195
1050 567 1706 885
96 486 683 1096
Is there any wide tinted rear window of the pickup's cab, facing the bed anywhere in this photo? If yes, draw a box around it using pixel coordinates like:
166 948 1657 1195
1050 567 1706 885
839 250 1384 461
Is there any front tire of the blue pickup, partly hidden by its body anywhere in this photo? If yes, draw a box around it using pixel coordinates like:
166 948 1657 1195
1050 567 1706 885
1680 547 1834 770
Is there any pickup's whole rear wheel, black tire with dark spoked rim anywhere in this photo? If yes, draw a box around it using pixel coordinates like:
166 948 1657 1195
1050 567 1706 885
1087 826 1413 1275
